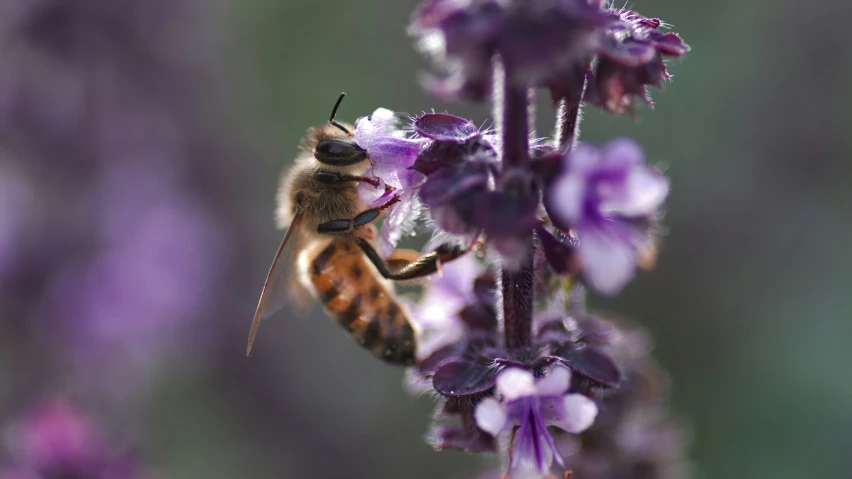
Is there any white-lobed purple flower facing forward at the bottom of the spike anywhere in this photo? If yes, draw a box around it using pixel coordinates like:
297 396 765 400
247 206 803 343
474 367 598 479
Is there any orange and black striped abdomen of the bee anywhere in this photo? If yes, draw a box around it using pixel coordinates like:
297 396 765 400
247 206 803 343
309 242 415 364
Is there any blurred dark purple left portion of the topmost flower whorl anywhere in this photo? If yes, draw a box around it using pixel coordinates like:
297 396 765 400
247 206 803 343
409 0 607 100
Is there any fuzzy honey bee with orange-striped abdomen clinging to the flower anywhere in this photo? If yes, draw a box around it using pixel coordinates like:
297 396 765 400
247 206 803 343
246 93 466 365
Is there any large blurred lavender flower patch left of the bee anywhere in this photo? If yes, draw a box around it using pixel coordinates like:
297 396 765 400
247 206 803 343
46 163 228 377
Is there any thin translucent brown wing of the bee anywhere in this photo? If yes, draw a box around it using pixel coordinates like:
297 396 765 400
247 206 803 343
246 210 302 356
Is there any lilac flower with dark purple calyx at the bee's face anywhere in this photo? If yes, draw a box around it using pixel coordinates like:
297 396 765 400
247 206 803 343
355 109 516 249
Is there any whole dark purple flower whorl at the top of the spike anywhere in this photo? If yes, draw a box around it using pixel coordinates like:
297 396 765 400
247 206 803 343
410 0 689 113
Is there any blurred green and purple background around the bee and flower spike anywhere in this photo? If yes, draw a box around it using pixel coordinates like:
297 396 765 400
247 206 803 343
0 0 852 479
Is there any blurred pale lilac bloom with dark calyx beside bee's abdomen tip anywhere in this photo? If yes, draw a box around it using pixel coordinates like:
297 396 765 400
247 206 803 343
407 266 505 452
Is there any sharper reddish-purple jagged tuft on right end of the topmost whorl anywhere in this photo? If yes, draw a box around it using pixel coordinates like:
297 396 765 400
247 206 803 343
585 10 689 114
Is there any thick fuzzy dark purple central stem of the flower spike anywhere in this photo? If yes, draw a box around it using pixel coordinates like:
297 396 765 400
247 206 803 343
494 65 535 352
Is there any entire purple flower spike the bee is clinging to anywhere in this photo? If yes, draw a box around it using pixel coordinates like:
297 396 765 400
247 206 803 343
355 0 688 479
